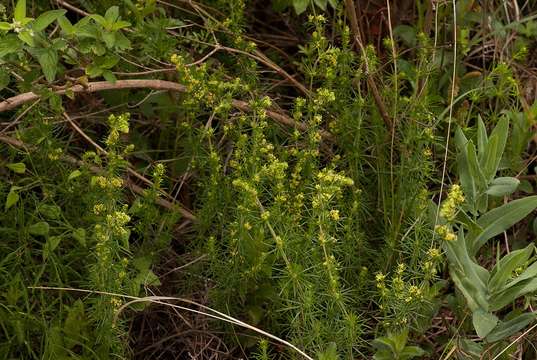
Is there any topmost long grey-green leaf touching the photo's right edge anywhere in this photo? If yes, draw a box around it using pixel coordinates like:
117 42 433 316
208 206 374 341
469 195 537 256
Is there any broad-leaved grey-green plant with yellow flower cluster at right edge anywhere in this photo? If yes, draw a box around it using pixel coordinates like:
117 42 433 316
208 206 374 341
436 117 537 343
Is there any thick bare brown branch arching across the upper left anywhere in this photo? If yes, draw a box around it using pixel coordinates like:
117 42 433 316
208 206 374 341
0 79 333 140
